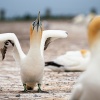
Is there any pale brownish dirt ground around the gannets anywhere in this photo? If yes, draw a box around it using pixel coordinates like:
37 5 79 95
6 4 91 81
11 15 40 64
0 21 88 100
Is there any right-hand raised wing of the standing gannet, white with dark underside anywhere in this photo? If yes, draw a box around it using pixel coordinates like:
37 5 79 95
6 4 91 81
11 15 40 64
42 30 68 50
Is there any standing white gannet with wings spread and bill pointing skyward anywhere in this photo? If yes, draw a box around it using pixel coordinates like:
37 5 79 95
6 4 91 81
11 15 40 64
0 13 68 92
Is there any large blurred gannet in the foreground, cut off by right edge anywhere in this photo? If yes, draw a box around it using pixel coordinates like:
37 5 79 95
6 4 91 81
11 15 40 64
71 16 100 100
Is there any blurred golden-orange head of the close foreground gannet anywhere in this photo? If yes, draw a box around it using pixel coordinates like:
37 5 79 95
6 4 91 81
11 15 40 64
88 16 100 47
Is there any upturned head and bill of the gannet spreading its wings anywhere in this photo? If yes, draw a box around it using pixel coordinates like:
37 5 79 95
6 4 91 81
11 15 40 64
30 12 42 40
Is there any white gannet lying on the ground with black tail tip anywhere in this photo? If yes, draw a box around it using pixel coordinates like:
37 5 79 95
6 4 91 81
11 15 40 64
45 49 90 72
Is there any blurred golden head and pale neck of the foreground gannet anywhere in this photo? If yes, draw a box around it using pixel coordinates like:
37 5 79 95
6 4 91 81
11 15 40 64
88 16 100 56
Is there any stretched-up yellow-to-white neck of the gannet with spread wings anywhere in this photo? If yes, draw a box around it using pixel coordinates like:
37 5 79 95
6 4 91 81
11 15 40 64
28 23 43 55
